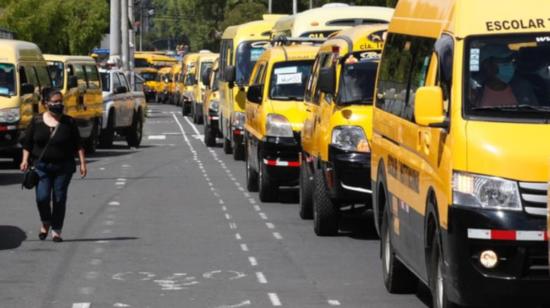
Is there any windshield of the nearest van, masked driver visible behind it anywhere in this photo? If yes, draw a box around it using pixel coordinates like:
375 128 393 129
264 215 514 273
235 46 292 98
464 34 550 122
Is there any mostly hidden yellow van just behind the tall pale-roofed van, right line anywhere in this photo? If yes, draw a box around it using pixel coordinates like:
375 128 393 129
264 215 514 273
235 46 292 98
202 58 221 147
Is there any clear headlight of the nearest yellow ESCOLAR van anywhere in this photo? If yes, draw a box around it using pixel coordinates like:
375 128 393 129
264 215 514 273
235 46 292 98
453 171 522 211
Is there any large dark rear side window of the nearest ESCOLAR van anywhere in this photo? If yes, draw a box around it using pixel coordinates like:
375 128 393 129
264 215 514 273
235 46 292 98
376 34 435 121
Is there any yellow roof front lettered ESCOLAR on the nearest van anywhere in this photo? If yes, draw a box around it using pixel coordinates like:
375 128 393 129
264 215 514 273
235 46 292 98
389 0 550 38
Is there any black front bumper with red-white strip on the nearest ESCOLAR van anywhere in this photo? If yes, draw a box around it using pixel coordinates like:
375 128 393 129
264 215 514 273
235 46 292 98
443 205 550 306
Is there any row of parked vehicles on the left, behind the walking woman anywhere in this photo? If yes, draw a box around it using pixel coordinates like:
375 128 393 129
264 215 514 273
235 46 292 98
0 40 147 166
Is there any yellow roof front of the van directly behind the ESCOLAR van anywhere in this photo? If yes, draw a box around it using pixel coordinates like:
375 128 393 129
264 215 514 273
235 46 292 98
321 25 388 55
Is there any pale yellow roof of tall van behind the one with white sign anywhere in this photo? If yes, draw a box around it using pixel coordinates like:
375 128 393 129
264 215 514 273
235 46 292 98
222 15 286 41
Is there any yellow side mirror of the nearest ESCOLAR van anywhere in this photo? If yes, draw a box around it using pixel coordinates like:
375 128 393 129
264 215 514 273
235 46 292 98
414 86 447 127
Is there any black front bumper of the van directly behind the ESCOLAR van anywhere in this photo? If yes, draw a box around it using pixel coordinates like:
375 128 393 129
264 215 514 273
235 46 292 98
323 145 372 206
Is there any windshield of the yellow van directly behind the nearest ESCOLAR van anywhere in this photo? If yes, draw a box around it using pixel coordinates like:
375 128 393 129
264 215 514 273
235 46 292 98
336 53 379 105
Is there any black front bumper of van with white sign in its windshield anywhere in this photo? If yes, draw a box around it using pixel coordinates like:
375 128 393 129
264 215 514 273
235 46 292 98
259 134 302 186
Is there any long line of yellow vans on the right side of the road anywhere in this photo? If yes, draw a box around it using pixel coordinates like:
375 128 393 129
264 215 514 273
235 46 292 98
153 0 550 308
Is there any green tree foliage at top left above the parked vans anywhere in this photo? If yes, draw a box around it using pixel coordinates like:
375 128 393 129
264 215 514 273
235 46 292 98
0 0 109 54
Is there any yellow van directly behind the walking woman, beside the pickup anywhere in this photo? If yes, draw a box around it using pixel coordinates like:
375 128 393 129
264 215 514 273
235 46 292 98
44 55 103 152
